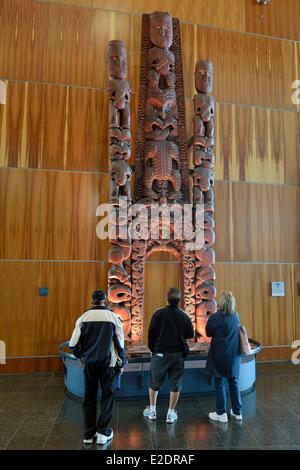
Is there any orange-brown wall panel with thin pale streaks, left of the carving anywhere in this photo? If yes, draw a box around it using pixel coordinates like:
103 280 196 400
0 81 113 172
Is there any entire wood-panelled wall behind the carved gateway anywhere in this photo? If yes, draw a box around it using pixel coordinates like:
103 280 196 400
0 0 300 373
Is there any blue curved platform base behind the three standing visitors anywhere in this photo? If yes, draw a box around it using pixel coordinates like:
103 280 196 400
59 340 261 398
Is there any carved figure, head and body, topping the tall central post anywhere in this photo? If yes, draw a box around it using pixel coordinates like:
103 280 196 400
148 12 176 89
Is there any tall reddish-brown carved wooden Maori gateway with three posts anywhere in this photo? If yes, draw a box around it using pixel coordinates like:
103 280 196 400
108 12 216 345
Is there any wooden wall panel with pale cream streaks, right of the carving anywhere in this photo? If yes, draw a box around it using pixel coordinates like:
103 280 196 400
215 103 300 184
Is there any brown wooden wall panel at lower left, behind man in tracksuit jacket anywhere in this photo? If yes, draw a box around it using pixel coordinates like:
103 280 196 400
0 261 108 357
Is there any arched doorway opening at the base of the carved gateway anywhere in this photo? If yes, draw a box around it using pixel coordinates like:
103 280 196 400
143 253 181 344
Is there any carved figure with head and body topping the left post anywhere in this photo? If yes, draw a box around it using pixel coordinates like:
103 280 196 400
107 40 130 129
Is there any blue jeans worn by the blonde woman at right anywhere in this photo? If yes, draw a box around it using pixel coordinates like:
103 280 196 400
215 377 242 415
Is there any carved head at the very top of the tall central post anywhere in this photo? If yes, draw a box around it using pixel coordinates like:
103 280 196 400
150 11 173 49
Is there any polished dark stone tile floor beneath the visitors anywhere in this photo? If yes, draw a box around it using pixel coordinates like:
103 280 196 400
0 363 300 450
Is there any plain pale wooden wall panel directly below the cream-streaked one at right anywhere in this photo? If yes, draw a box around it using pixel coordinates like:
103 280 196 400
232 183 299 262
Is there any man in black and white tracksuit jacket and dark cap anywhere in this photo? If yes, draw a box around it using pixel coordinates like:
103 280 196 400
69 290 126 444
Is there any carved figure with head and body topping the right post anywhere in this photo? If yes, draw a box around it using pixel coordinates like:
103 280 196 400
194 60 214 137
